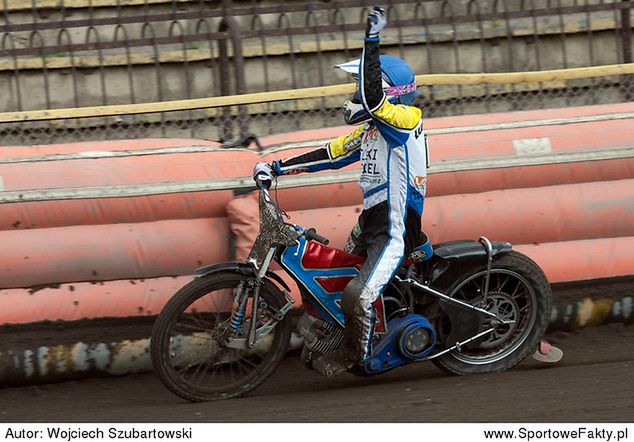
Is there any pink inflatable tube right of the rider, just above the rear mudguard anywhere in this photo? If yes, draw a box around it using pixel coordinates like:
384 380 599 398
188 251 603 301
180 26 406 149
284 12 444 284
423 179 634 244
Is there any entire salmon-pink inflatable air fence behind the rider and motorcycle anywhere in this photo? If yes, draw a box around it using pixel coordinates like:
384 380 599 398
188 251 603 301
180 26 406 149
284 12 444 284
0 103 634 323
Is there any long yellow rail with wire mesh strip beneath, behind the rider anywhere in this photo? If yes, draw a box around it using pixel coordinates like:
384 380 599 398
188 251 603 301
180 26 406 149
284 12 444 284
0 63 634 145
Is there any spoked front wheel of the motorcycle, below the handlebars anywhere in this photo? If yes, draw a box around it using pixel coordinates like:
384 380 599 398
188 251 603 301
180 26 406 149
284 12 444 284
150 271 291 402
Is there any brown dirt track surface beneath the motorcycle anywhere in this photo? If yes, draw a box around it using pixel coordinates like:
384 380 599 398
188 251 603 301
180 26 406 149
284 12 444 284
0 324 634 422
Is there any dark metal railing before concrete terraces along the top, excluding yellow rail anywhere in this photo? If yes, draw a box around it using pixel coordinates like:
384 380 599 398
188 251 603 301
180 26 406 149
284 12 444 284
0 0 634 143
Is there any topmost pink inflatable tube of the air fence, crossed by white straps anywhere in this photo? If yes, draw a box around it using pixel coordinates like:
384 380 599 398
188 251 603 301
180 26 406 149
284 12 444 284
0 103 634 230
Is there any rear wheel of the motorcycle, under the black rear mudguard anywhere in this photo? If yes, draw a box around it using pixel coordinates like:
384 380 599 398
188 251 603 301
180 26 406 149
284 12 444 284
433 251 552 375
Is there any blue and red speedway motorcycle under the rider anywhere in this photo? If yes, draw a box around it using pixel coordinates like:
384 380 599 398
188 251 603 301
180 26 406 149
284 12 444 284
151 182 551 401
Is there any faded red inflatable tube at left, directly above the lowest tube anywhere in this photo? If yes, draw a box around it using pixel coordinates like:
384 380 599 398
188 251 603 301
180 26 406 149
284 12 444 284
0 218 229 288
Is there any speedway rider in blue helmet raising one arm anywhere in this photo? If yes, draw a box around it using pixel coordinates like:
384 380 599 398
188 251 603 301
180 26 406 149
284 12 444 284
254 7 427 376
